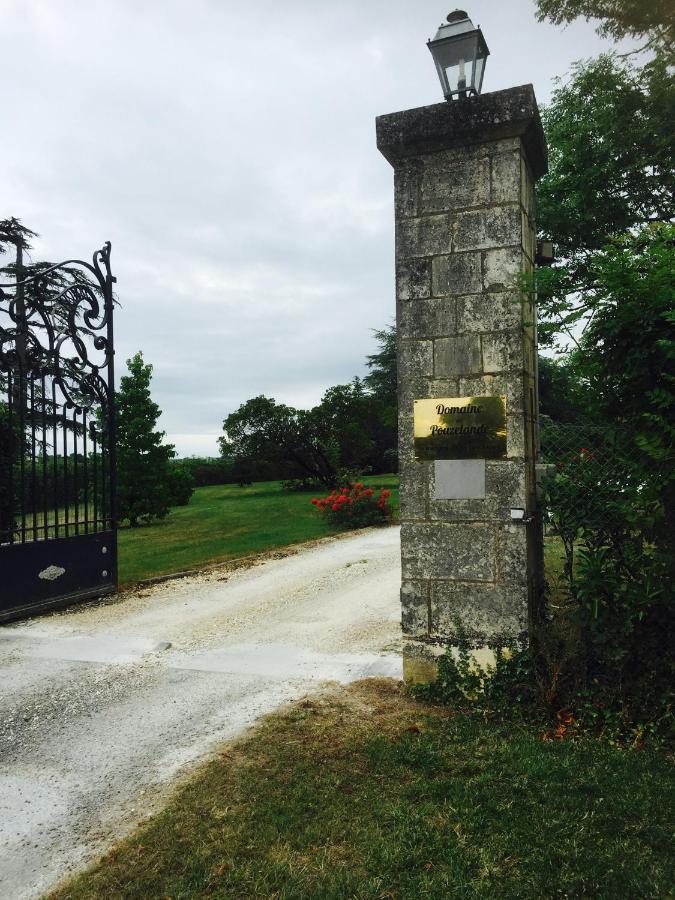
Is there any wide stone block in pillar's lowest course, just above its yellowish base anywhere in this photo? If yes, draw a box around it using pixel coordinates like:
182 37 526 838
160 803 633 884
430 580 528 647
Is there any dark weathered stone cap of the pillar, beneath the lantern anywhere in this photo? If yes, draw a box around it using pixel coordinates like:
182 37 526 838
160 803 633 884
375 84 548 179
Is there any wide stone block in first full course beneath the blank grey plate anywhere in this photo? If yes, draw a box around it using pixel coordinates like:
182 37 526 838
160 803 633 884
401 522 495 581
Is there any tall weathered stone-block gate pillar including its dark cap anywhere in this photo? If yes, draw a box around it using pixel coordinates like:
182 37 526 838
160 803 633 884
377 85 547 681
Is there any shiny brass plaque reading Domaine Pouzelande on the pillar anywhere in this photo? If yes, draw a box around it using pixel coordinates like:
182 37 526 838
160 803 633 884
414 397 506 459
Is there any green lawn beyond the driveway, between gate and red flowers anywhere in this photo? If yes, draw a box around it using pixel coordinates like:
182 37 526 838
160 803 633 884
118 475 398 584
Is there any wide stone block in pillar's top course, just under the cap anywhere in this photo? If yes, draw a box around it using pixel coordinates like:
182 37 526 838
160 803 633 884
420 158 492 214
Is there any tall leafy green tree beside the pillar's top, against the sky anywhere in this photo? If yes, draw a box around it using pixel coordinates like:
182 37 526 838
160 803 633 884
537 56 675 349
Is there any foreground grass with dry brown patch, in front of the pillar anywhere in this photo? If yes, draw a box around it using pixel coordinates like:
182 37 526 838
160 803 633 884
50 680 675 900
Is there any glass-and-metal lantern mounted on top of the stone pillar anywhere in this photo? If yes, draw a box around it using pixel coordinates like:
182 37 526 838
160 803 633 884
427 9 490 100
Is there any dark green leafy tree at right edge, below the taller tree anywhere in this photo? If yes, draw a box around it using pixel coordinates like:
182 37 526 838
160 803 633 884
577 224 675 540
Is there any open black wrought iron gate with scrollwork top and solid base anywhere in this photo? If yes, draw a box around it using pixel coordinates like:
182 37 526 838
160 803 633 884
0 243 117 621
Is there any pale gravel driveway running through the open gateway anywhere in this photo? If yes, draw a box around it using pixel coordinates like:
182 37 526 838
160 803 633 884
0 528 401 900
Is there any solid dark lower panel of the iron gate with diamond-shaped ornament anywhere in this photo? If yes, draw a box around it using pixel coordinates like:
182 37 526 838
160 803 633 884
0 531 117 622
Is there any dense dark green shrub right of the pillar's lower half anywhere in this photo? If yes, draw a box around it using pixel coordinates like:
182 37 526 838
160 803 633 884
537 426 675 731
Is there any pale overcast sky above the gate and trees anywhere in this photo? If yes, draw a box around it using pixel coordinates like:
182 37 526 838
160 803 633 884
0 0 624 455
